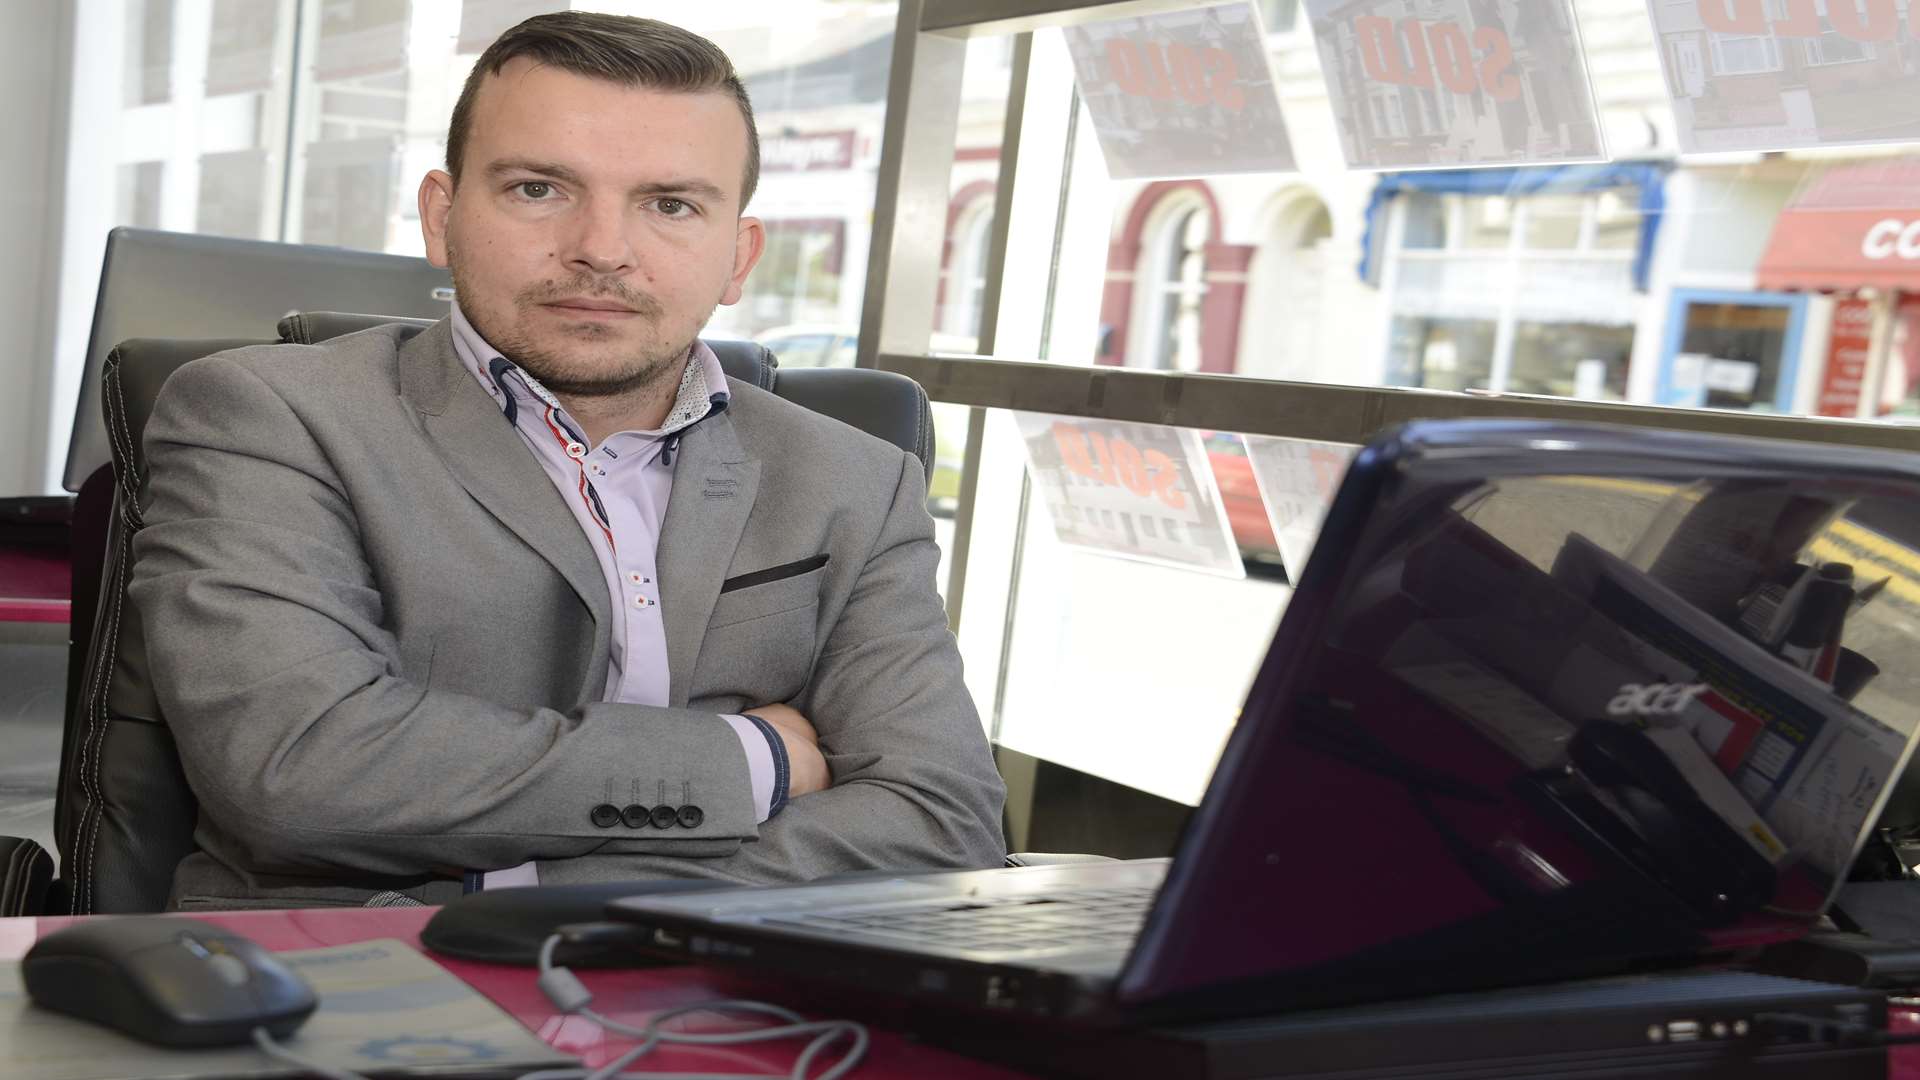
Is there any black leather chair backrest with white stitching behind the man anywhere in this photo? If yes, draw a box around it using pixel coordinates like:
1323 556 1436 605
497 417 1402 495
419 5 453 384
52 311 933 915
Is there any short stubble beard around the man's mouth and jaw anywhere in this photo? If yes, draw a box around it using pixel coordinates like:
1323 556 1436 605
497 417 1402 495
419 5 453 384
447 244 710 398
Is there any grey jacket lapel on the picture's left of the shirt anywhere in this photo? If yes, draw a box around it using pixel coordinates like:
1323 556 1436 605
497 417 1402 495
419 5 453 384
399 319 612 668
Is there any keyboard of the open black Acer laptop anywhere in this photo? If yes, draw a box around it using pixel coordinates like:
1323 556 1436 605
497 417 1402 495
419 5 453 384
764 886 1158 953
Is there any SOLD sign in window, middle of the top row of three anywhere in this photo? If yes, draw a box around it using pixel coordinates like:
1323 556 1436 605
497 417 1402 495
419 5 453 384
1308 0 1607 169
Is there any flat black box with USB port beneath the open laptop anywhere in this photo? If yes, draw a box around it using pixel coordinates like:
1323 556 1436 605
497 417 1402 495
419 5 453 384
918 972 1887 1080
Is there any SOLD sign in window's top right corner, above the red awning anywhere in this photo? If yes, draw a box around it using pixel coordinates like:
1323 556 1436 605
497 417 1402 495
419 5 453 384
1647 0 1920 152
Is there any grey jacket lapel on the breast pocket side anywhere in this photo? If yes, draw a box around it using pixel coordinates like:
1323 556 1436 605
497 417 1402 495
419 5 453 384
657 403 760 707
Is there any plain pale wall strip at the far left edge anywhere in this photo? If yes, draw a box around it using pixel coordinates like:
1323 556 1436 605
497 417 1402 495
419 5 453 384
0 0 71 496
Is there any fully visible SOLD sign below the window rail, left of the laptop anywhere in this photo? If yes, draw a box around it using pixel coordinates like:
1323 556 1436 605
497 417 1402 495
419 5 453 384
1016 413 1246 577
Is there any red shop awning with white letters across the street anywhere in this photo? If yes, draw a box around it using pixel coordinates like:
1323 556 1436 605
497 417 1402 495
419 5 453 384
1759 158 1920 290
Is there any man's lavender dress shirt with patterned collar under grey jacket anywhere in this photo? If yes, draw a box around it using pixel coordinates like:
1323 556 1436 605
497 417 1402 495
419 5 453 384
453 304 787 888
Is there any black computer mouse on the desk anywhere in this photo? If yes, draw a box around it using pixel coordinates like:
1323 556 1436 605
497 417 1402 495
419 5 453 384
21 915 319 1045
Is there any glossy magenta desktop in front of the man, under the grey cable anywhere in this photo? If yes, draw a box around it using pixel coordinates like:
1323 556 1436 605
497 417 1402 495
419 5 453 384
0 907 1020 1080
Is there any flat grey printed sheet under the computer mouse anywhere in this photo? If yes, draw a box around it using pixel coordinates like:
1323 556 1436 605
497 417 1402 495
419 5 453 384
0 940 574 1080
